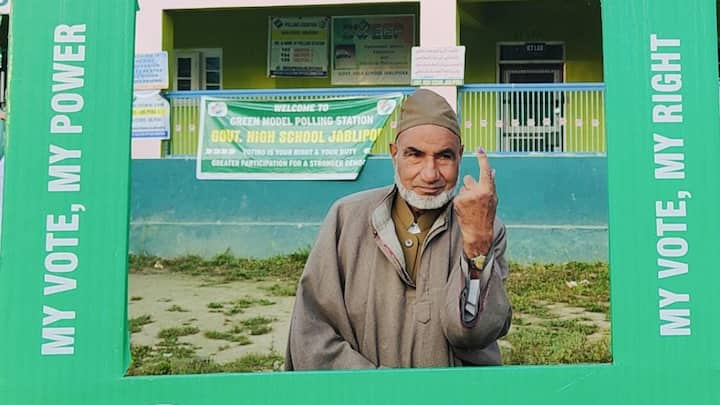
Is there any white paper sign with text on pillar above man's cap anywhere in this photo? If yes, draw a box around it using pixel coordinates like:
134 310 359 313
410 46 465 86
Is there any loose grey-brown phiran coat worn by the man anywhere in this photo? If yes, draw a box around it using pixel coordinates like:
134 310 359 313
285 186 511 370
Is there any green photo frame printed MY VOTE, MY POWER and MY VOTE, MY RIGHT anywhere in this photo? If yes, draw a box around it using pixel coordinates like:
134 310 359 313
0 0 720 405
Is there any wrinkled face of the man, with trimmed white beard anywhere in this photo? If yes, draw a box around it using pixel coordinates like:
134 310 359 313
390 124 463 209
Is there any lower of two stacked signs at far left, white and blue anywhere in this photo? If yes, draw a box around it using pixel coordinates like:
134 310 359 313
132 91 170 139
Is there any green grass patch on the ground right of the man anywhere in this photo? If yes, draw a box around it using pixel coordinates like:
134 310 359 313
501 262 612 364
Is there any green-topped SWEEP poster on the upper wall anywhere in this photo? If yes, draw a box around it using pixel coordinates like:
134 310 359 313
331 14 415 85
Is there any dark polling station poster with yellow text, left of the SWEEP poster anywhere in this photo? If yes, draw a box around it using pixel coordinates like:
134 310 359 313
268 17 330 77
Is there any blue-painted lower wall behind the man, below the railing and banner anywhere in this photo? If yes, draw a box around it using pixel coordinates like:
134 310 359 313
130 154 608 262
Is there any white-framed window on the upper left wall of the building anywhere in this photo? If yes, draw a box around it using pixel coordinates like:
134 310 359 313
173 48 222 90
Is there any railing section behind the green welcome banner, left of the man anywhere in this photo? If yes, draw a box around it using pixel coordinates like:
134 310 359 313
164 87 415 156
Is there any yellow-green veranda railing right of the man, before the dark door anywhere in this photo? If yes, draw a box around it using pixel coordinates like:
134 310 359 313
458 83 605 153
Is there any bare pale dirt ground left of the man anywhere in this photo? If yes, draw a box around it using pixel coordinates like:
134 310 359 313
128 273 295 364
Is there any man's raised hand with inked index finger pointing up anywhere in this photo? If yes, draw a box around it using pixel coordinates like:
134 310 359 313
453 148 498 258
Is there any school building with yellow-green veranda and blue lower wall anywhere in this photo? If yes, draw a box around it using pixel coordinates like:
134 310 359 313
130 0 607 262
